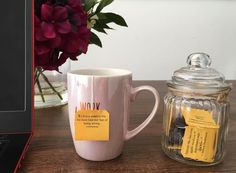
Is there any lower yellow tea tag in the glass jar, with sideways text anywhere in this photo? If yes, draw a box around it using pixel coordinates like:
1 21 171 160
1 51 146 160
181 126 218 163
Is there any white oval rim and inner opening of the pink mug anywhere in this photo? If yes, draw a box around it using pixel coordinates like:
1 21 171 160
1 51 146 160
67 68 132 77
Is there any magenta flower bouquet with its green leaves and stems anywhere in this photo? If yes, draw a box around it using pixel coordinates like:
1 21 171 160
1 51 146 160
34 0 127 102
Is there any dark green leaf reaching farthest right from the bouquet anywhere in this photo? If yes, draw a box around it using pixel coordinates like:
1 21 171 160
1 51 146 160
101 13 128 27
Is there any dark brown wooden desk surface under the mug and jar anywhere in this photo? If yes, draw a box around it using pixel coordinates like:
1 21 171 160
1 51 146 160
19 81 236 173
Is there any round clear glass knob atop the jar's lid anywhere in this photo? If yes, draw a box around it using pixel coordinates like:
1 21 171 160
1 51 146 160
187 53 211 68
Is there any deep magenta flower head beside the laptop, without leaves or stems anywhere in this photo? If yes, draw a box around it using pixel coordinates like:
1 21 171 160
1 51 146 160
34 0 91 71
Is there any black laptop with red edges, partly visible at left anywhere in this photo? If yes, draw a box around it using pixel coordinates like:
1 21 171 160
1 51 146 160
0 0 34 173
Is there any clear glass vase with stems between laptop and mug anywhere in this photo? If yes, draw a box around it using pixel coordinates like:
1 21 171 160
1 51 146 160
34 60 71 109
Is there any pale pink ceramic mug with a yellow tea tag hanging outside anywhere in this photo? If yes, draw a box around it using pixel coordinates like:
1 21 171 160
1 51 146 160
67 69 160 161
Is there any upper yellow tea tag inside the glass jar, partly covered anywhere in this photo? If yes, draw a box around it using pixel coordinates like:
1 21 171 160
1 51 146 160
182 107 219 128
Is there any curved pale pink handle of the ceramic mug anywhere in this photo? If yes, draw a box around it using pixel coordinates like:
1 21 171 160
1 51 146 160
125 86 160 140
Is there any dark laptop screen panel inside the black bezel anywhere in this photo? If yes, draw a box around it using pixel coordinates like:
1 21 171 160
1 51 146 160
0 0 26 111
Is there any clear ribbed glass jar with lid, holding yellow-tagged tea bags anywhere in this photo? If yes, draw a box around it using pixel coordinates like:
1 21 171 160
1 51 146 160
162 53 232 166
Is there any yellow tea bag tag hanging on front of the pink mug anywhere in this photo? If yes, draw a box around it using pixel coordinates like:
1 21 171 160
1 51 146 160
75 110 110 141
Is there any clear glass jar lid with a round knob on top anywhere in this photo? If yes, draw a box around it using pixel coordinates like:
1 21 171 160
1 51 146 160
167 53 230 91
